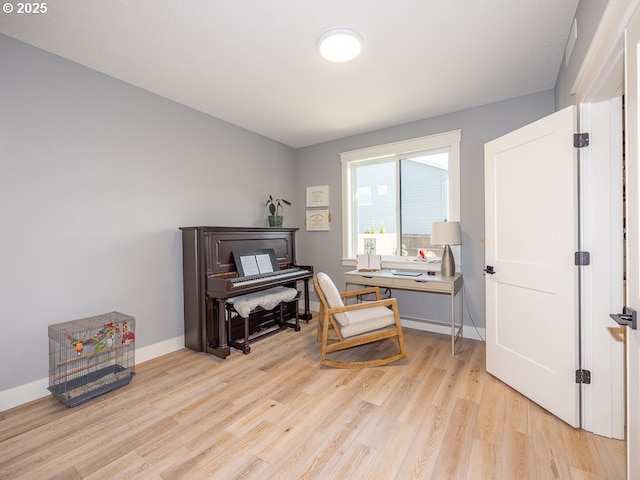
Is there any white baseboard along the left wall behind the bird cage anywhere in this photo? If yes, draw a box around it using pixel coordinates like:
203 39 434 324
0 336 184 412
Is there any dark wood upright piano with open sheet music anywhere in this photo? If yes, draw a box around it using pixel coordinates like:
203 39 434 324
180 227 313 358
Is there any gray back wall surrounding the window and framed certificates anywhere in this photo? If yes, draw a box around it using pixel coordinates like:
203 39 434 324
296 90 554 327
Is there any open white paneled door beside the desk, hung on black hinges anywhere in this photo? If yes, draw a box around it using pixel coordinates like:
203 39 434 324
485 106 580 427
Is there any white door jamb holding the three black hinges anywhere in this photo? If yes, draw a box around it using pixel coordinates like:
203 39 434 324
578 95 625 439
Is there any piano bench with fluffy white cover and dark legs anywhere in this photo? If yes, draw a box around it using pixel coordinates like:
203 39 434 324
226 287 300 355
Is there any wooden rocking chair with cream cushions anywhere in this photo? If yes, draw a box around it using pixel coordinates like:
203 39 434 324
313 272 407 368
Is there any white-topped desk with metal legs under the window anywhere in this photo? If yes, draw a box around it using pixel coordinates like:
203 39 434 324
344 270 464 355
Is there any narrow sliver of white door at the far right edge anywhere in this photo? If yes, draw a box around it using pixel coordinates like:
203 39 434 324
625 7 640 479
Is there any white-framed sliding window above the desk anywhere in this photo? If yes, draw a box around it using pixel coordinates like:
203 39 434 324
340 130 461 262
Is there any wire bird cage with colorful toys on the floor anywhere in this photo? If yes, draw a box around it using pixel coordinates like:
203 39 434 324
49 312 135 407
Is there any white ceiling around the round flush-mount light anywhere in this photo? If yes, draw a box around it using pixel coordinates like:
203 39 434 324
0 0 578 147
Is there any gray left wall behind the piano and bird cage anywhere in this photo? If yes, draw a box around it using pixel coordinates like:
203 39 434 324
0 35 299 395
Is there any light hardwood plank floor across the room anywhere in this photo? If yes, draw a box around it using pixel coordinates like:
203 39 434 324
0 320 625 480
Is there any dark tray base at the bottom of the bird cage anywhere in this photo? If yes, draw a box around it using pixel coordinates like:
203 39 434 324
48 365 135 408
